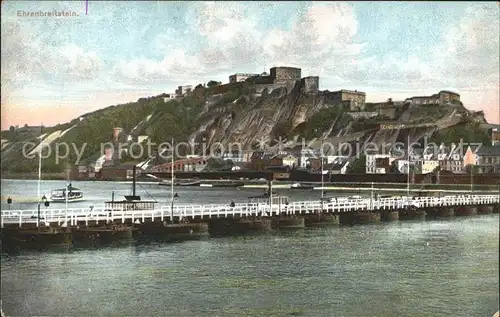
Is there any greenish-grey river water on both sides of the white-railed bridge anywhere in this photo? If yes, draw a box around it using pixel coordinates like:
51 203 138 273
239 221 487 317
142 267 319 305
1 180 499 317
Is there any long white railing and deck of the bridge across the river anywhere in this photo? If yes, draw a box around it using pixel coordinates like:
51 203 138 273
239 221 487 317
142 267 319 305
1 195 499 228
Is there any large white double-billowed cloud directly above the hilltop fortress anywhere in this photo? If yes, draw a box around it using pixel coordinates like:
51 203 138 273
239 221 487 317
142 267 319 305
113 2 362 84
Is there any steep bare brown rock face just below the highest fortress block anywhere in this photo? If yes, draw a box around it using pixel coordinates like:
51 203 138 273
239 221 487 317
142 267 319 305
194 82 335 148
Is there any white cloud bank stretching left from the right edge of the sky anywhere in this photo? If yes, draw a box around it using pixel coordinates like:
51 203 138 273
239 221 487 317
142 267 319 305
342 2 500 121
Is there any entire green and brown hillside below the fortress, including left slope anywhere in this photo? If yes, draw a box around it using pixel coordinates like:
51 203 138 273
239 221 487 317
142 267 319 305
1 81 486 172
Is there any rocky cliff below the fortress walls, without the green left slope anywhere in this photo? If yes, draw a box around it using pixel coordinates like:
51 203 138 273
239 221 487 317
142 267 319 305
190 81 485 152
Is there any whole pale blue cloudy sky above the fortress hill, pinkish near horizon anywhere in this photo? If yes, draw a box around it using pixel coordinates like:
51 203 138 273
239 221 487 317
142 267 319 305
1 0 500 129
